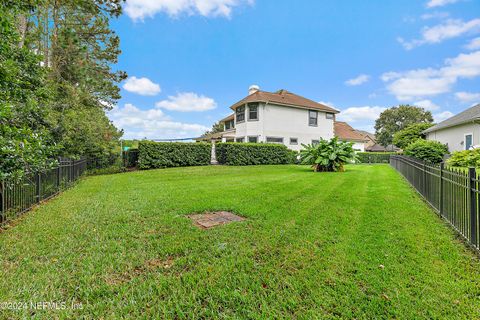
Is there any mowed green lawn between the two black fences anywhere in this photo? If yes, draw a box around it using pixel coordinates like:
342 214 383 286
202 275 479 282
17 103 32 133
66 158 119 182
0 165 480 319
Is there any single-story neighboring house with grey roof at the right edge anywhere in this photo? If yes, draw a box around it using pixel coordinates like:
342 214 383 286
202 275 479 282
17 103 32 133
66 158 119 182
423 104 480 152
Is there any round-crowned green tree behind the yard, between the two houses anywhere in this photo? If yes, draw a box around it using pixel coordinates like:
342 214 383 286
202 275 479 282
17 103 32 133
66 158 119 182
375 105 433 146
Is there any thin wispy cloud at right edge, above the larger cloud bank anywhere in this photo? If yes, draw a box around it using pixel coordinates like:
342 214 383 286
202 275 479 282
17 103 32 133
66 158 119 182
397 19 480 50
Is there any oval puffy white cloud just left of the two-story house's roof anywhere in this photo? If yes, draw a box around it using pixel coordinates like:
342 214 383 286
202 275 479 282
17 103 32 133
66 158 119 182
155 92 217 112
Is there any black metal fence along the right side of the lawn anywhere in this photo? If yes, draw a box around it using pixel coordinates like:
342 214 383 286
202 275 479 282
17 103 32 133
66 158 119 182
390 156 480 253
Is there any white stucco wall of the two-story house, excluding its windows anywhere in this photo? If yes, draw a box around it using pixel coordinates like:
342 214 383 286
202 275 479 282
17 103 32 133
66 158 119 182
235 103 334 150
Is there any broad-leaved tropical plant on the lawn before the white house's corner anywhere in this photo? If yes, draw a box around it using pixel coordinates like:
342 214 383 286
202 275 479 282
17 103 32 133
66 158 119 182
300 138 357 172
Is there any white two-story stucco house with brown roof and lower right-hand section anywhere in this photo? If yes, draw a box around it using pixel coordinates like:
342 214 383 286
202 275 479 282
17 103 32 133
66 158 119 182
199 86 366 151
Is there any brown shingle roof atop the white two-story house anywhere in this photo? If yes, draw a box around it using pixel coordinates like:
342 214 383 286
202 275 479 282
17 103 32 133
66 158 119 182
230 89 339 113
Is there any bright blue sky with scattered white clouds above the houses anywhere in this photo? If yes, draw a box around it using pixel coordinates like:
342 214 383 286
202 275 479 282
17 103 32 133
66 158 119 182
109 0 480 139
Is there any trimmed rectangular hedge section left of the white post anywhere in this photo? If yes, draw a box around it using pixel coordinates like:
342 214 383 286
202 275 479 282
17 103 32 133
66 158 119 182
138 141 211 169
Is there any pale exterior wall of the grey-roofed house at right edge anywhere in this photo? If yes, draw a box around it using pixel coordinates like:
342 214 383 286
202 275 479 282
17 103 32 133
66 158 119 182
426 123 480 152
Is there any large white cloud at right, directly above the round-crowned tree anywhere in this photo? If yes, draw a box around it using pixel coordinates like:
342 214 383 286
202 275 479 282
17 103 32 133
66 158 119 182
381 51 480 100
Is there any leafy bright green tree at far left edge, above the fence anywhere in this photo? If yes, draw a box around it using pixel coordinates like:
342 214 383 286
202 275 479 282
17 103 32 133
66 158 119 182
0 1 55 179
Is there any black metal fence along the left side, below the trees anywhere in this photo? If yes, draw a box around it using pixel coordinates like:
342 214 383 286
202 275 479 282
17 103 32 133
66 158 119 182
0 159 92 227
